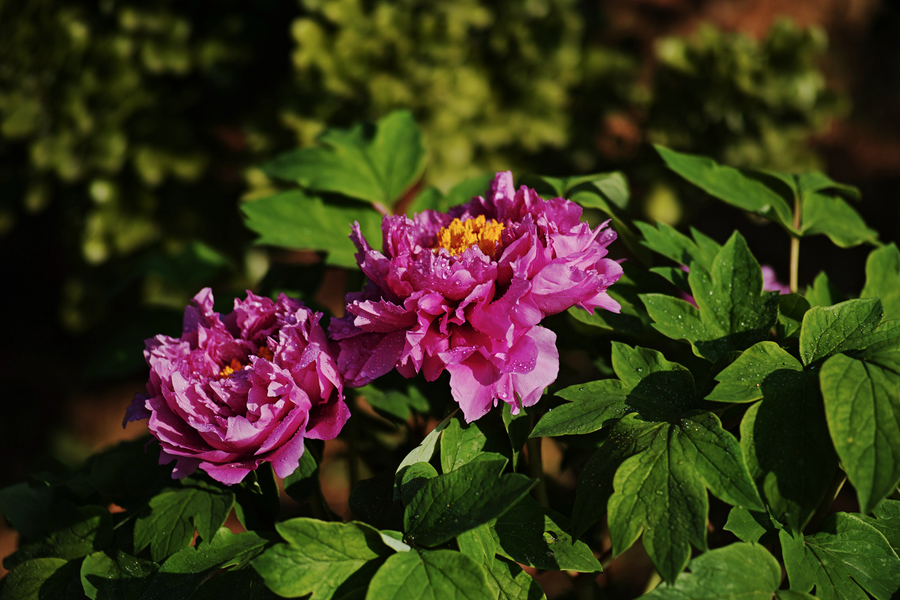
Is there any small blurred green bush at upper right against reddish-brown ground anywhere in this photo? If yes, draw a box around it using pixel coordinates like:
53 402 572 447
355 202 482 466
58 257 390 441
647 21 839 172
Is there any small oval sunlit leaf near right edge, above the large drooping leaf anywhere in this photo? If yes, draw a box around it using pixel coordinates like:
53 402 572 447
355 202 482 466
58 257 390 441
800 298 884 365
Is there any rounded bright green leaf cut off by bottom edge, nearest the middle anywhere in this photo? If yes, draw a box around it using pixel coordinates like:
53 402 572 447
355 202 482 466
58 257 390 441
366 550 496 600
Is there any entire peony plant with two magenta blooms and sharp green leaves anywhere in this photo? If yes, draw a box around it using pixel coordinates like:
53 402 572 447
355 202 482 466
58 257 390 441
0 112 900 600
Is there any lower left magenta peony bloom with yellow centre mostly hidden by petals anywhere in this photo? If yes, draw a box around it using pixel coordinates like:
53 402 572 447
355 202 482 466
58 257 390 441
123 288 350 485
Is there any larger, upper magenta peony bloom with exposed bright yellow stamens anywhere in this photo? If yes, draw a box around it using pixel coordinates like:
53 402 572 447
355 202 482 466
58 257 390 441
329 172 622 422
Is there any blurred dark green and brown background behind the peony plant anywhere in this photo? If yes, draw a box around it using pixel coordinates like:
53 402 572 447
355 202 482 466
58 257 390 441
0 0 900 500
